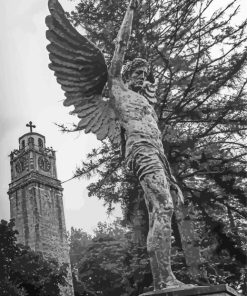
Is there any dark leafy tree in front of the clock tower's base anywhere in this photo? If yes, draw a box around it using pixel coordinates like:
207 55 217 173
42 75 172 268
0 220 67 296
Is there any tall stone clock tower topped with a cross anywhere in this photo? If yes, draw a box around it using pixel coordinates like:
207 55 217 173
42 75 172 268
8 121 74 296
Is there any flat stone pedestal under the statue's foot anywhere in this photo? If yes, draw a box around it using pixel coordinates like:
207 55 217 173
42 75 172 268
140 285 240 296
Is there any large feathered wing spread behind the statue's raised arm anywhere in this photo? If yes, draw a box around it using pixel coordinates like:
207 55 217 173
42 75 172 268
46 0 120 143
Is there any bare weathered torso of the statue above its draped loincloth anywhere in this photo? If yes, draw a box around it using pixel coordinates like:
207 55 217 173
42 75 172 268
112 81 163 155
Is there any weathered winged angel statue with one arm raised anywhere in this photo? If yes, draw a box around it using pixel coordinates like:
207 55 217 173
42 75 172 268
46 0 188 290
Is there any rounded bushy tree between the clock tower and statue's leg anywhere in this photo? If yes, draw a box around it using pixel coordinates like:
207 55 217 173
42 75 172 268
70 219 151 296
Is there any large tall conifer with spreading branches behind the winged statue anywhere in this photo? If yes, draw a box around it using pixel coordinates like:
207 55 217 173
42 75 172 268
62 0 247 288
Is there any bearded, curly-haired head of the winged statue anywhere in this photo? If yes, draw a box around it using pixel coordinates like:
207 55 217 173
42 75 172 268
122 58 149 92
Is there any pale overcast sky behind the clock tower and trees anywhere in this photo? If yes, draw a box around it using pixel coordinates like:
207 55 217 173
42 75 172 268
0 0 247 233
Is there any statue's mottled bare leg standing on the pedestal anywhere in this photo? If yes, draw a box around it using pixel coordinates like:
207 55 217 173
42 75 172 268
140 170 182 289
